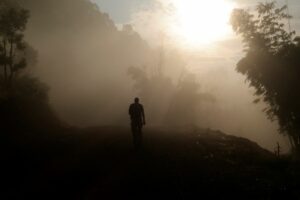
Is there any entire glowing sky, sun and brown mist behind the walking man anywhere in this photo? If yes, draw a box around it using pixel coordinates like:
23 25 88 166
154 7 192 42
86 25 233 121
20 0 299 151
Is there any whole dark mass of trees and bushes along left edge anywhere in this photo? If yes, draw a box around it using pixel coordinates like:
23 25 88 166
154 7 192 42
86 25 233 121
0 1 58 135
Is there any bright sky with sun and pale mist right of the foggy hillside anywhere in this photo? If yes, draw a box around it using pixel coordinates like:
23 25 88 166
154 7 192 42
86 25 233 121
89 0 299 150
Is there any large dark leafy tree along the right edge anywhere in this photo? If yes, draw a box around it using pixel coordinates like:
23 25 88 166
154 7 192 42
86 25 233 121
231 2 300 152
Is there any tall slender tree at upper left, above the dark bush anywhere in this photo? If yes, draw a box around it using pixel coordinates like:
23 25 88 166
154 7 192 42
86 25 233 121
0 7 29 86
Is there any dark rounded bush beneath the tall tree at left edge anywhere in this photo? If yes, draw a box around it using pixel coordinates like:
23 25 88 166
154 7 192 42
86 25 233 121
0 75 61 138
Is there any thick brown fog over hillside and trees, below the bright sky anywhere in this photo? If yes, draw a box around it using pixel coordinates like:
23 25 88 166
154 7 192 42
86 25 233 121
13 0 288 151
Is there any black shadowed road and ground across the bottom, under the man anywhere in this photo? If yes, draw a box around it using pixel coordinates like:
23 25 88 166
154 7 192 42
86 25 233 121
0 127 300 200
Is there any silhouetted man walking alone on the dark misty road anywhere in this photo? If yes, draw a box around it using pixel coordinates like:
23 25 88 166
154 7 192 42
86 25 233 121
129 98 146 149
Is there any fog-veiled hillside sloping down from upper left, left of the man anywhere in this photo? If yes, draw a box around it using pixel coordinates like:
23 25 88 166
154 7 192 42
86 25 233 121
0 0 152 126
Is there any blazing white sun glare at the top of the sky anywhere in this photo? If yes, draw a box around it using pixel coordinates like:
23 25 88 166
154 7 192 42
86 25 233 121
169 0 234 47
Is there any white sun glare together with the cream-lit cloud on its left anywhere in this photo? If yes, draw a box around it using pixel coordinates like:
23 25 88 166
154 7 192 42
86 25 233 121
127 0 235 50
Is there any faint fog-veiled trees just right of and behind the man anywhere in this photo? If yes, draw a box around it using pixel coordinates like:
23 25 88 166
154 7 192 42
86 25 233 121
128 67 215 126
